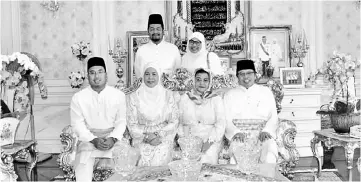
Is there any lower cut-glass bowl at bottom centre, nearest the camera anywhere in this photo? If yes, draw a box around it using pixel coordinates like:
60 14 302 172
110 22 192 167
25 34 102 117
168 159 202 181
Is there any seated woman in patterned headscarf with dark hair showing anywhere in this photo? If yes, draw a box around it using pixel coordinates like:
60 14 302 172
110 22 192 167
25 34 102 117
179 69 226 164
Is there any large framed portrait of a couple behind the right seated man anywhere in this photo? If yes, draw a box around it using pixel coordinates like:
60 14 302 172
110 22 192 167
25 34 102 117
248 25 292 78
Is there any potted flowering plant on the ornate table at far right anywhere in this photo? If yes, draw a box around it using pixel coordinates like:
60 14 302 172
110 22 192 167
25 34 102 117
317 52 360 133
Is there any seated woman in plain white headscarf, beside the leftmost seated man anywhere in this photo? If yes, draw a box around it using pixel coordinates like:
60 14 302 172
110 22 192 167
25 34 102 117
127 63 179 166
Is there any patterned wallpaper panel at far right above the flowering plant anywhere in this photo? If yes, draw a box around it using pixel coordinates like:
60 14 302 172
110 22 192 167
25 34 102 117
323 1 360 59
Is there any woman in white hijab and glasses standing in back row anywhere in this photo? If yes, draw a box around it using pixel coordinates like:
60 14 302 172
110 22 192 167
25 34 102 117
181 32 224 75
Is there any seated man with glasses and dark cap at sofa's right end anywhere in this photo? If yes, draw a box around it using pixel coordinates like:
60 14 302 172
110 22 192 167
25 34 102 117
224 60 278 176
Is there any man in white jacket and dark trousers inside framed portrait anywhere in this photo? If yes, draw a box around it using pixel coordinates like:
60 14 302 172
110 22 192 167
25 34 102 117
258 35 271 77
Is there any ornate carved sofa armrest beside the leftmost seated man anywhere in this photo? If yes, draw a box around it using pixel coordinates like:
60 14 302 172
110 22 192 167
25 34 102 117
57 125 78 181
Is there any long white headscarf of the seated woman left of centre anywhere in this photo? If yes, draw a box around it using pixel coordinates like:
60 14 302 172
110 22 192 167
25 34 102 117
137 62 166 120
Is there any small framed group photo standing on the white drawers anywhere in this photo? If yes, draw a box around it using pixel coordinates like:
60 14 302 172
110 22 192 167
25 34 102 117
280 67 305 88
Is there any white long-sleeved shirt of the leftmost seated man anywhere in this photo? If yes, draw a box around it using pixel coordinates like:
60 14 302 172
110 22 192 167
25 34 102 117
70 86 126 141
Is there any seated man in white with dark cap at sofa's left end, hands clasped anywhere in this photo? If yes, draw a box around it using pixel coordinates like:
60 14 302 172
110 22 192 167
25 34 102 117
70 57 126 181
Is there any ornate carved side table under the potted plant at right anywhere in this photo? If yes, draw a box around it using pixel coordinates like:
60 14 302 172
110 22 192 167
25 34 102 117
311 129 361 181
